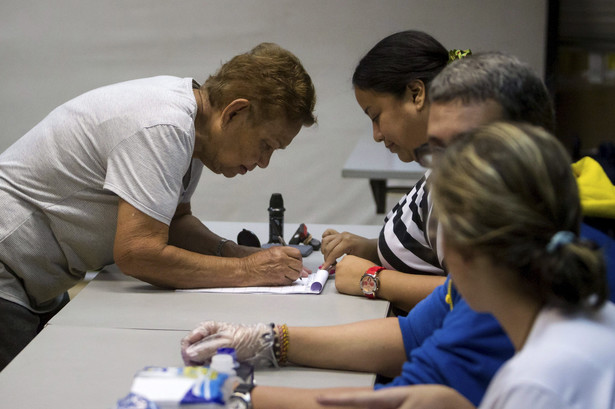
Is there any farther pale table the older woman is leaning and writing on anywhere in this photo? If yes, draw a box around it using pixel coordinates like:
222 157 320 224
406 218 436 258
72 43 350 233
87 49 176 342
50 222 389 331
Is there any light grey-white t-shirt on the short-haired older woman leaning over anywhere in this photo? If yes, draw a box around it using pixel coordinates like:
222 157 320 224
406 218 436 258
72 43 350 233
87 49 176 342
0 76 203 312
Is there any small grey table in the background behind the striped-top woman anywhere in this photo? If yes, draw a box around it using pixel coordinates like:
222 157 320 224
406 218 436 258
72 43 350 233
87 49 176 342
342 138 426 214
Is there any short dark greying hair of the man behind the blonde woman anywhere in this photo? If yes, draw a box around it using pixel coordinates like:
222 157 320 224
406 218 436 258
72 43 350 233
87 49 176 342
428 52 555 132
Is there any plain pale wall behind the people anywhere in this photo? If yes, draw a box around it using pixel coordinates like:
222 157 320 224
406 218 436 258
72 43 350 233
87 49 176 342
0 0 546 226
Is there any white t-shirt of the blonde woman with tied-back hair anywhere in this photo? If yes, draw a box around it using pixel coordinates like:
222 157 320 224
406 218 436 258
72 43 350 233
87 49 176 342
480 302 615 409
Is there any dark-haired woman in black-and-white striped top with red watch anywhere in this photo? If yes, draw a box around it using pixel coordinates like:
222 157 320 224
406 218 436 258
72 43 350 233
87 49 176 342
322 30 471 315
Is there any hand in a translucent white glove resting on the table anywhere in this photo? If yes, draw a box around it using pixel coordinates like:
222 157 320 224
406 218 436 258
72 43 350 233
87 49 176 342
181 321 278 368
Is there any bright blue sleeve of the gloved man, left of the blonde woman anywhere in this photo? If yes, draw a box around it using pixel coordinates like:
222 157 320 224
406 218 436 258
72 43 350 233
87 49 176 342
376 278 514 406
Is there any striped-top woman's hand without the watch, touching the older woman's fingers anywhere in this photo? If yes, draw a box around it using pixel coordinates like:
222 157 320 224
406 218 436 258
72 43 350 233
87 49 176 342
320 229 378 272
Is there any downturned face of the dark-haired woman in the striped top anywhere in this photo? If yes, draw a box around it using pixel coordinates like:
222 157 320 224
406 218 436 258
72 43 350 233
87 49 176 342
355 87 429 162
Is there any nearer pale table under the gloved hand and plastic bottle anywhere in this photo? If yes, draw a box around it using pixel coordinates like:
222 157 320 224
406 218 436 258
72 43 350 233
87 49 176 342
0 325 373 409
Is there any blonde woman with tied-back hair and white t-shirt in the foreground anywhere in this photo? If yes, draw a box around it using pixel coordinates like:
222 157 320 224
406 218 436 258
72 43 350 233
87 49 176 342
321 122 615 409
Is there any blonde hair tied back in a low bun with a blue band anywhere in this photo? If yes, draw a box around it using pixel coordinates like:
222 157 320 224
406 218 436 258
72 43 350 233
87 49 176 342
432 122 608 308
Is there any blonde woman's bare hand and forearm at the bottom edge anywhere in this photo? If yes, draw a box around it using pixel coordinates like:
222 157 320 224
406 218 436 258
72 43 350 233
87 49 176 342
316 385 476 409
